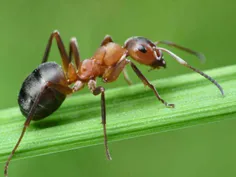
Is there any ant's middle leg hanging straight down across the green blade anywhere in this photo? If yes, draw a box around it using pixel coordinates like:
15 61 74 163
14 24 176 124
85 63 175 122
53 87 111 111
88 80 112 160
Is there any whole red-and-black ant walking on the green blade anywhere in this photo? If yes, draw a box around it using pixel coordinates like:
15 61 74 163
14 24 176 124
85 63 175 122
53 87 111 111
4 31 224 177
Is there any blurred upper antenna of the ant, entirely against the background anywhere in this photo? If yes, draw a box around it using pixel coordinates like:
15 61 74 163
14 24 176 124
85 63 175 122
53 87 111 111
154 41 206 62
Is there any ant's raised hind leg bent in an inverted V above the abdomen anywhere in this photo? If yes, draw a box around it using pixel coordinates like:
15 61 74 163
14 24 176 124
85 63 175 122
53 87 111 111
42 30 71 73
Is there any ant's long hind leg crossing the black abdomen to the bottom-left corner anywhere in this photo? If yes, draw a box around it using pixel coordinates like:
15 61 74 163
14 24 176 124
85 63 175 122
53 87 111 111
4 82 72 177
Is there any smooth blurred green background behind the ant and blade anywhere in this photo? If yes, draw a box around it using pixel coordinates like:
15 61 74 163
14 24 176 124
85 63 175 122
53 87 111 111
0 0 236 177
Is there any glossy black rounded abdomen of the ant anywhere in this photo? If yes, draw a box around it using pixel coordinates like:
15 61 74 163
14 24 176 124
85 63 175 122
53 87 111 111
18 62 67 120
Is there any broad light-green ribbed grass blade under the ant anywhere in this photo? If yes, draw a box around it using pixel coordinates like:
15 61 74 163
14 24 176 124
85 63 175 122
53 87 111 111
0 65 236 162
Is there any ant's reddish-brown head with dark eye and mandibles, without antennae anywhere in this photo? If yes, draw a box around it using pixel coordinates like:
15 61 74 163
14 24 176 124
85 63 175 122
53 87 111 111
124 37 166 68
